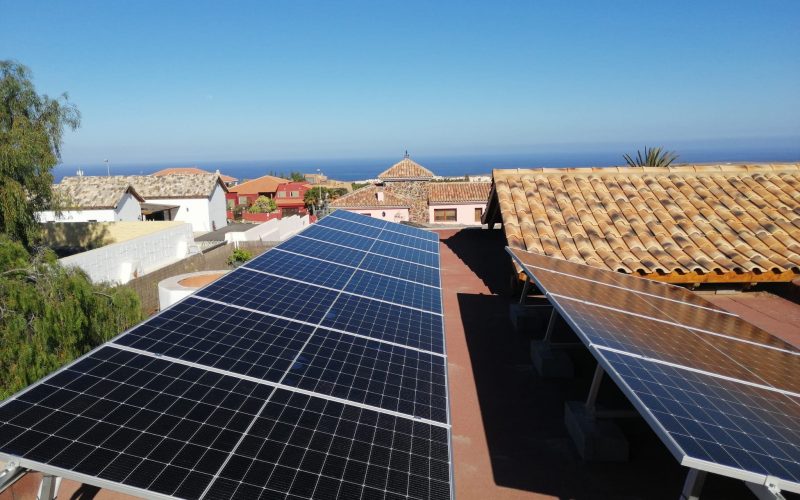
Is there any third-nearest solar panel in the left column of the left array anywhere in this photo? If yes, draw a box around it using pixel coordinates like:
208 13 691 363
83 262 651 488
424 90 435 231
197 268 338 323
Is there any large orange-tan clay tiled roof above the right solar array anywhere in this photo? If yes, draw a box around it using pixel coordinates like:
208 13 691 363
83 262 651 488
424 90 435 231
484 164 800 283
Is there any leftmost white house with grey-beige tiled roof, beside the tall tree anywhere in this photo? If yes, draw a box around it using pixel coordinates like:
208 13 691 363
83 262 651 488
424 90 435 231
36 177 144 222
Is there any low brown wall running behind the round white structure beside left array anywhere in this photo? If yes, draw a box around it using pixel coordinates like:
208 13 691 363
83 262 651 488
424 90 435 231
128 242 274 316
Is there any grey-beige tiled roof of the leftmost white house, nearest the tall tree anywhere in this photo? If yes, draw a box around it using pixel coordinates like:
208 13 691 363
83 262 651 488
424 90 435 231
53 177 144 210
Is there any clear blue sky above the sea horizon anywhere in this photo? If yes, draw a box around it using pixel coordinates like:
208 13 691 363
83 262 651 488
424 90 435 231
0 0 800 164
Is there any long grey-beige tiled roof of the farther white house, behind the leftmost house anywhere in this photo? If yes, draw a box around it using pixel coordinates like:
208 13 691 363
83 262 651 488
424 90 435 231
61 174 228 200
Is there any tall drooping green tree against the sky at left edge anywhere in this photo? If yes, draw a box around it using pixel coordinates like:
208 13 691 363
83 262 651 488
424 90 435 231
0 61 80 248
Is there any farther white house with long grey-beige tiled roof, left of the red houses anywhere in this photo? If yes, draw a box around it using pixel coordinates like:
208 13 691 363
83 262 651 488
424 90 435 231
59 174 228 232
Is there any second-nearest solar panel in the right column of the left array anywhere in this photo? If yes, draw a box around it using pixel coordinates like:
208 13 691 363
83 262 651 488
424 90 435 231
283 329 447 423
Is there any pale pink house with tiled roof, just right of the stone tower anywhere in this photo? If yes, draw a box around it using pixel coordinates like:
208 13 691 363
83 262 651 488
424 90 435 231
427 182 491 225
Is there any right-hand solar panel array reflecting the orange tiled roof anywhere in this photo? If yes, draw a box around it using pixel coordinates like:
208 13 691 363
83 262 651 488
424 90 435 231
507 248 800 492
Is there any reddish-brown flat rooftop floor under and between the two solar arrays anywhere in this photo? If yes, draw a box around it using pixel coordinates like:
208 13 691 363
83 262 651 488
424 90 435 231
0 229 800 500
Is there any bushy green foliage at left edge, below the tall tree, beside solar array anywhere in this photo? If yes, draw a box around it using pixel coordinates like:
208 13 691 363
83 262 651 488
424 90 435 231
0 235 142 399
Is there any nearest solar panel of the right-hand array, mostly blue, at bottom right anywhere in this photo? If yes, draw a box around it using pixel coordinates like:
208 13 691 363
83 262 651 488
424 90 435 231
599 349 800 490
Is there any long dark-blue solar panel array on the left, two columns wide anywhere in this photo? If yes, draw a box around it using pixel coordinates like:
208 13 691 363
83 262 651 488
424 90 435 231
0 211 452 499
